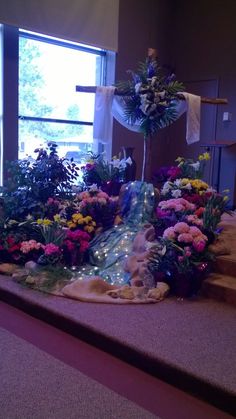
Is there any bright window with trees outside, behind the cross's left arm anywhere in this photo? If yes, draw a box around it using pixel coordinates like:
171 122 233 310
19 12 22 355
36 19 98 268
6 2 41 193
18 31 107 163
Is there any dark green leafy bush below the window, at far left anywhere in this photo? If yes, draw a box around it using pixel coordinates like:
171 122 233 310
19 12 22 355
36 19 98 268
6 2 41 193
1 143 78 220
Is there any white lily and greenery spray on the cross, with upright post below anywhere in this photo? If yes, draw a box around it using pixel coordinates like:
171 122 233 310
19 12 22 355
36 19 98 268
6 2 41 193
116 49 184 181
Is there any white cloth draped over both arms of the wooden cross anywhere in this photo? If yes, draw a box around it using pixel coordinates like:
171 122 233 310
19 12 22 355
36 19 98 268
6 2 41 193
93 86 201 144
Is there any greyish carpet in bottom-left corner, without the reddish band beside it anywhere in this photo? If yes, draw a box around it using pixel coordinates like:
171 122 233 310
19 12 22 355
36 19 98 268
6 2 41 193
0 328 159 419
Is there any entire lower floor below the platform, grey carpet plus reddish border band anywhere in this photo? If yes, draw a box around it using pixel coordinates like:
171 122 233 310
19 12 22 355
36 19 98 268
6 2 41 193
0 302 232 419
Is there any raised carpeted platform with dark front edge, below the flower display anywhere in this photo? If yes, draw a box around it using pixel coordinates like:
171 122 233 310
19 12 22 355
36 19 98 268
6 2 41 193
0 276 236 414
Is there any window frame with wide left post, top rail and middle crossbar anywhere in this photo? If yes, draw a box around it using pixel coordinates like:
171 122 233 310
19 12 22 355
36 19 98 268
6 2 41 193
0 24 116 184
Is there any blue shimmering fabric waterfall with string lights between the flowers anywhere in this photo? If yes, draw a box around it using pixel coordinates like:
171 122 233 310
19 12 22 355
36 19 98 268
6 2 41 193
75 181 155 285
